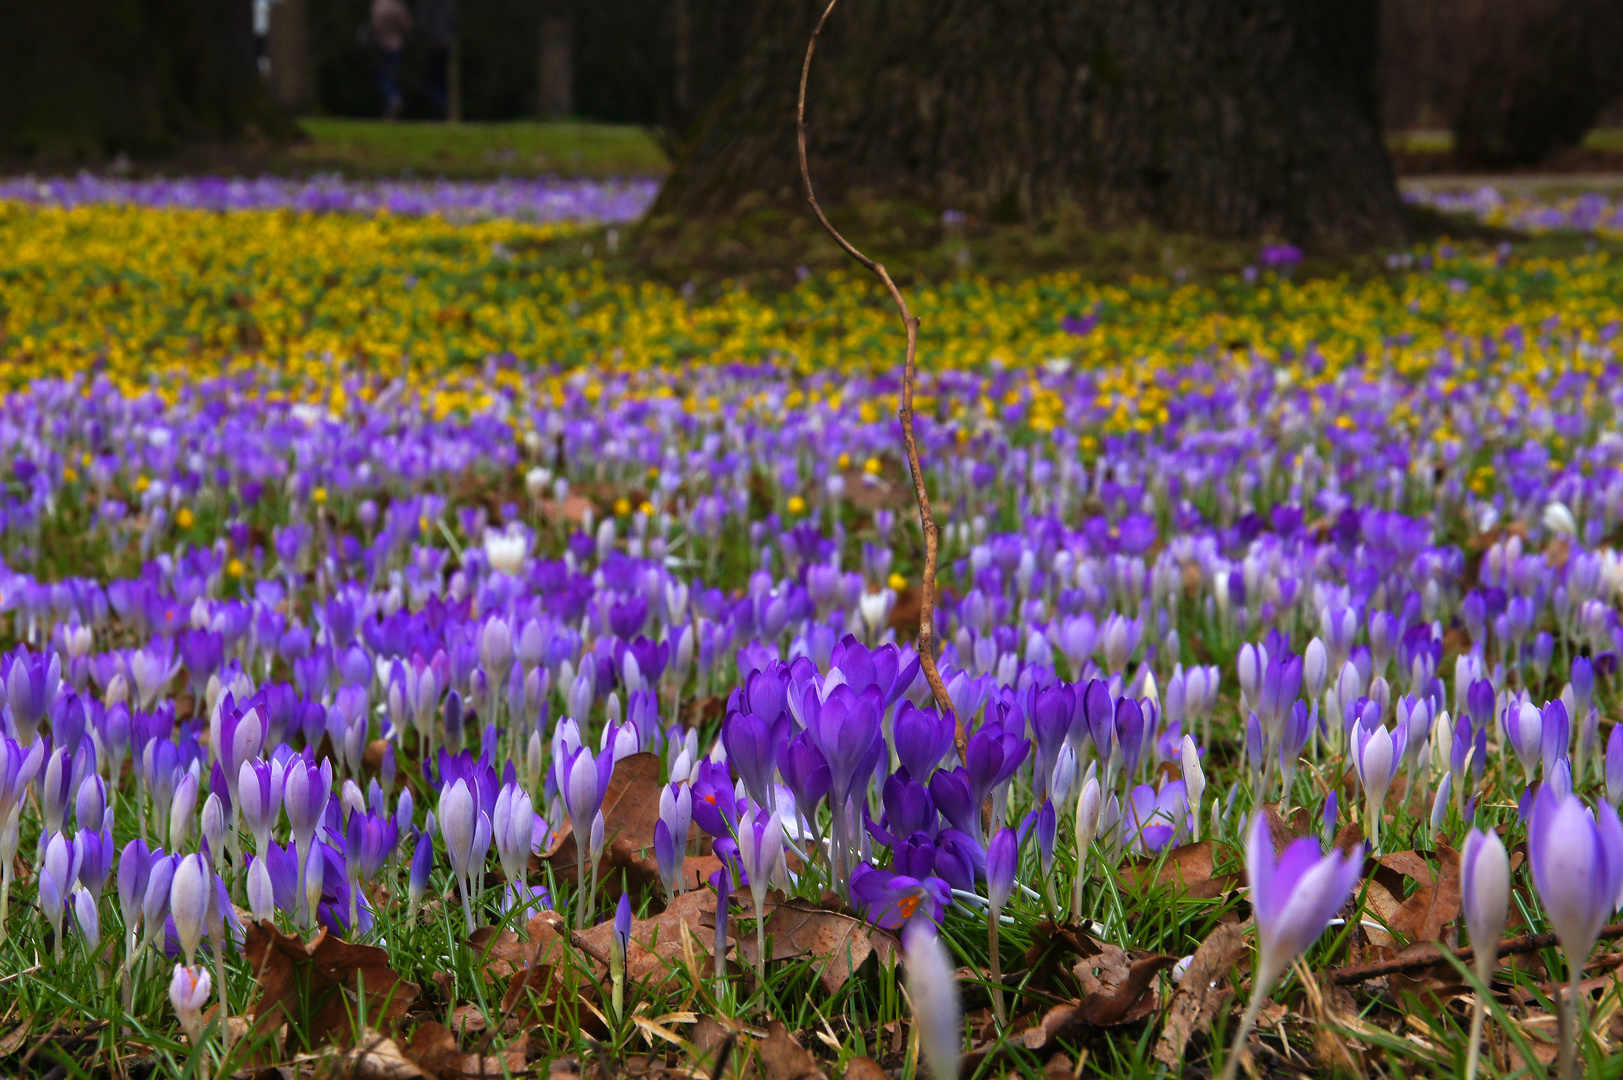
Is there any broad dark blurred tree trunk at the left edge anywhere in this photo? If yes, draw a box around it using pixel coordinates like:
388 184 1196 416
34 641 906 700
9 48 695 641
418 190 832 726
0 0 286 162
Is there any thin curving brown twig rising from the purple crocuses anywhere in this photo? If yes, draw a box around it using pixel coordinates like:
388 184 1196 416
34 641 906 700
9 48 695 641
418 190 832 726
795 0 969 763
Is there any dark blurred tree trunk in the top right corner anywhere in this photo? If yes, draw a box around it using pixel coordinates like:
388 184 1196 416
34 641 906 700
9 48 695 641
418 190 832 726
1453 0 1623 166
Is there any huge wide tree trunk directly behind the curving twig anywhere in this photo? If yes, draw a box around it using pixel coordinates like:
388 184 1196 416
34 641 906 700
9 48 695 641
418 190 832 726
654 0 1402 250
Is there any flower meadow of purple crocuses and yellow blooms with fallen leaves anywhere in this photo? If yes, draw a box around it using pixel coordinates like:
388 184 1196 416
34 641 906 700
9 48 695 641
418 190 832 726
0 189 1623 1080
